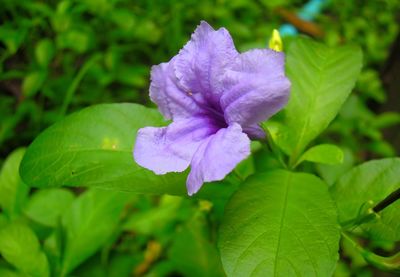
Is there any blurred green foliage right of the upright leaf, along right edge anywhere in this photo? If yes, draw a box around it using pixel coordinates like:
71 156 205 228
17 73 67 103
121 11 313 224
320 0 400 161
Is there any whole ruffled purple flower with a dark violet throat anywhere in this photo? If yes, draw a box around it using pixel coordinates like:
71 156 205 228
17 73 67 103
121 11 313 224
134 21 290 195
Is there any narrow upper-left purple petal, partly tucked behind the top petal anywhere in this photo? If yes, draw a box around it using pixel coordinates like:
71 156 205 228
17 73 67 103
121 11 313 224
150 58 200 119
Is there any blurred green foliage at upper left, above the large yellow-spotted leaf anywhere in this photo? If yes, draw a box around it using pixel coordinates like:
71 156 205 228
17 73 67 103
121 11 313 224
0 0 301 154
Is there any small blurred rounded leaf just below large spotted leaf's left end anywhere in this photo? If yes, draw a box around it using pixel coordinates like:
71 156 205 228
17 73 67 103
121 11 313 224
25 188 75 227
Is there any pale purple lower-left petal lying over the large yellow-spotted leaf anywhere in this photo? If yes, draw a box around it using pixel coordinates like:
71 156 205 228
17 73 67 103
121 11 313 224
133 117 218 174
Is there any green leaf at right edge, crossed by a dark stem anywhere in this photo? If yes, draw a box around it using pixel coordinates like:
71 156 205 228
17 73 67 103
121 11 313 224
331 158 400 241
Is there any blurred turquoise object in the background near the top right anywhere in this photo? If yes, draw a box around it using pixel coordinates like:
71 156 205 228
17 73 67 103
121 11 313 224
279 0 329 37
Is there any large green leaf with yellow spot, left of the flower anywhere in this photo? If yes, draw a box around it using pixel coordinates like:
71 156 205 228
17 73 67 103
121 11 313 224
21 104 186 194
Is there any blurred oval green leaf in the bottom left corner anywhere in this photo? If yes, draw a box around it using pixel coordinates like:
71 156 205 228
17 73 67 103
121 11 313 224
0 222 49 277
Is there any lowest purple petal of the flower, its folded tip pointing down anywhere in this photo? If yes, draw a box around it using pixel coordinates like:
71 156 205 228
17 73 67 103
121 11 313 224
186 123 250 195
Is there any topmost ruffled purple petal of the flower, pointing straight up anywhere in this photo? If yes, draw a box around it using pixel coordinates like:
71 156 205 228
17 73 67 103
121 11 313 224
175 21 238 108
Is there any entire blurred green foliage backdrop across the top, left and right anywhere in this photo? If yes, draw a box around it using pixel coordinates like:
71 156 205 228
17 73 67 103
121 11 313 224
0 0 400 160
